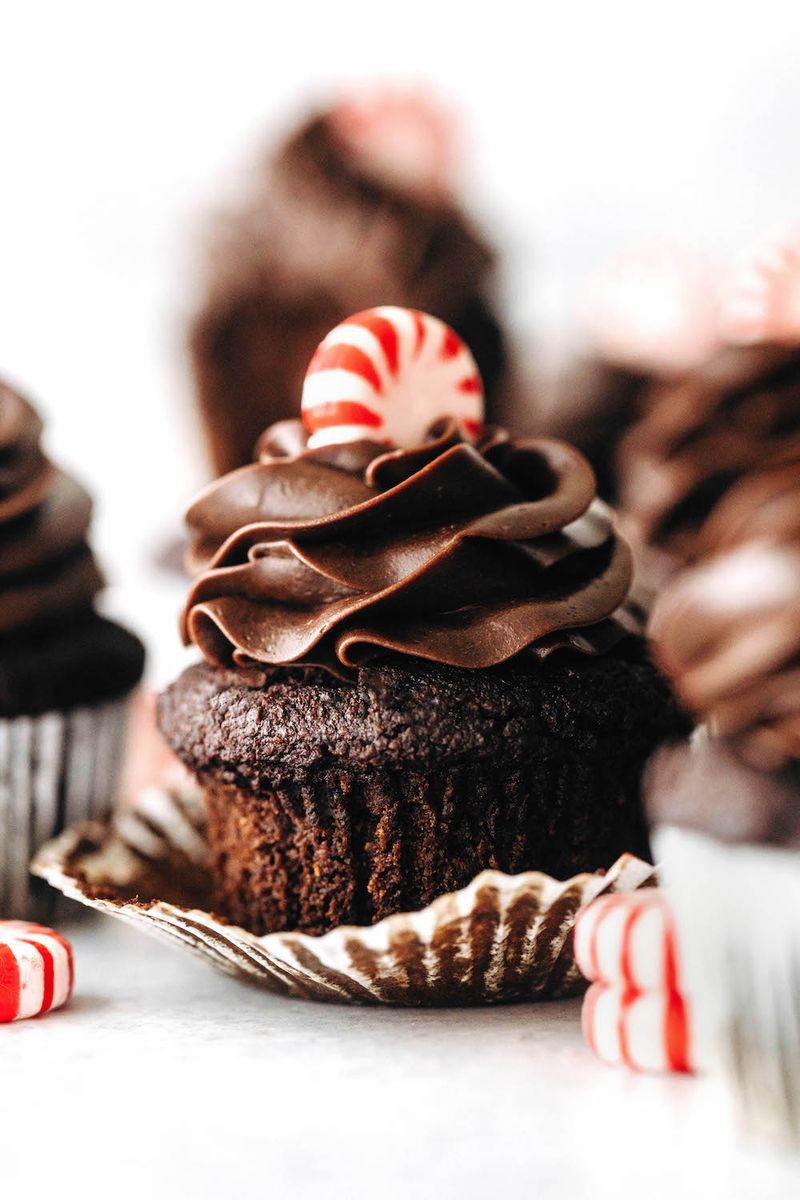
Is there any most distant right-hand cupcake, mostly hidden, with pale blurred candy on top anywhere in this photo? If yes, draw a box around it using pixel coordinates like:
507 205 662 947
545 246 718 503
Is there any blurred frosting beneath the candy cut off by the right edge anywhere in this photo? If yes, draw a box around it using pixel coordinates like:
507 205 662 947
619 344 800 562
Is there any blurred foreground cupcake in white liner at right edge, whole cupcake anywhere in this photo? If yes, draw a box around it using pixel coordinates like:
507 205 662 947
646 450 800 1145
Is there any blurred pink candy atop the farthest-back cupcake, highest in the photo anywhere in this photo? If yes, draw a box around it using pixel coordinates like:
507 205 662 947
327 88 459 196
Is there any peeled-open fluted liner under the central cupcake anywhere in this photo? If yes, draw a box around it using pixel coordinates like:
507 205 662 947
32 782 655 1006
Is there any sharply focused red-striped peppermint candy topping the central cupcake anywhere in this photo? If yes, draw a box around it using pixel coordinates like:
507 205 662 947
302 306 483 449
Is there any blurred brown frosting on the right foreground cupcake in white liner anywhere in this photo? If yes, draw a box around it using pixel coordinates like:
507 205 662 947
650 454 800 768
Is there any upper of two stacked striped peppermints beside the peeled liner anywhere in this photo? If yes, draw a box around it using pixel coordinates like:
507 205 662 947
575 888 680 991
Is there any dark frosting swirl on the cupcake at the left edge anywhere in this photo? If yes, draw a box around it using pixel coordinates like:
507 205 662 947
0 382 103 635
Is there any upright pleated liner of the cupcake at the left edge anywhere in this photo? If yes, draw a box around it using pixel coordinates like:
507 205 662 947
0 698 127 920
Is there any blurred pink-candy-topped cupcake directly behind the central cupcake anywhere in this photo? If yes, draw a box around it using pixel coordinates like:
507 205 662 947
191 90 505 473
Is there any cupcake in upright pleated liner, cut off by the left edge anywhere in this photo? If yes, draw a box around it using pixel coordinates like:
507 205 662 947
0 383 144 917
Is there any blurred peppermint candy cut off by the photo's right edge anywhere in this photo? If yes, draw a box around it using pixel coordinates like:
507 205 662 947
722 226 800 346
